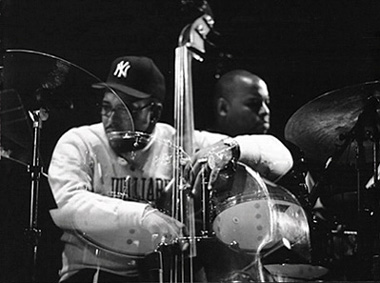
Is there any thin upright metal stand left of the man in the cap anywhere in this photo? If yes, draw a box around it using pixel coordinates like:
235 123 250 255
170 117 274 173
25 108 48 282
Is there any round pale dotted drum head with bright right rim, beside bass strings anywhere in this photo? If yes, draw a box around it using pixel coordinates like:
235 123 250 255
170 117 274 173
213 163 274 252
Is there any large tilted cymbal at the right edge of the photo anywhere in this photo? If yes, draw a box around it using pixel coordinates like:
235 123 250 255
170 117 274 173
285 81 380 164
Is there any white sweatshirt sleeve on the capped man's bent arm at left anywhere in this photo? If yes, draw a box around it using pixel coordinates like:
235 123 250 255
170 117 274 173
48 131 147 237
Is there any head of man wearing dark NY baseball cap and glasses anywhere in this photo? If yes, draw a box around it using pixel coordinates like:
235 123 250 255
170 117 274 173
93 56 165 136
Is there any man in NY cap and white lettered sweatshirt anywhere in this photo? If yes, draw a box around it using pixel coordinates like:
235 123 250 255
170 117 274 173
48 56 293 282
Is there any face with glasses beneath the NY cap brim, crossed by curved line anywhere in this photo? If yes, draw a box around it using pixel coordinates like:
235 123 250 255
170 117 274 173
101 92 153 133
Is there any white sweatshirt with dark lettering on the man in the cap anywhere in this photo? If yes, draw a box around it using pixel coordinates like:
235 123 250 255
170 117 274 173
49 123 293 280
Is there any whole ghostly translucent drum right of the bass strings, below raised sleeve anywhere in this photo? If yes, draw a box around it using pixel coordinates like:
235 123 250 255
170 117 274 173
209 163 310 258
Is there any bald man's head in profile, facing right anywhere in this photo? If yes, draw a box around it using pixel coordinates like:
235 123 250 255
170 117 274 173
215 70 270 136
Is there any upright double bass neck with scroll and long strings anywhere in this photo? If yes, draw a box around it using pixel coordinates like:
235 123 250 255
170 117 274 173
162 1 214 282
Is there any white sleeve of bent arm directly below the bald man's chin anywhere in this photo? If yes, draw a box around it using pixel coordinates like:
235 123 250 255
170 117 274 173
234 135 293 181
